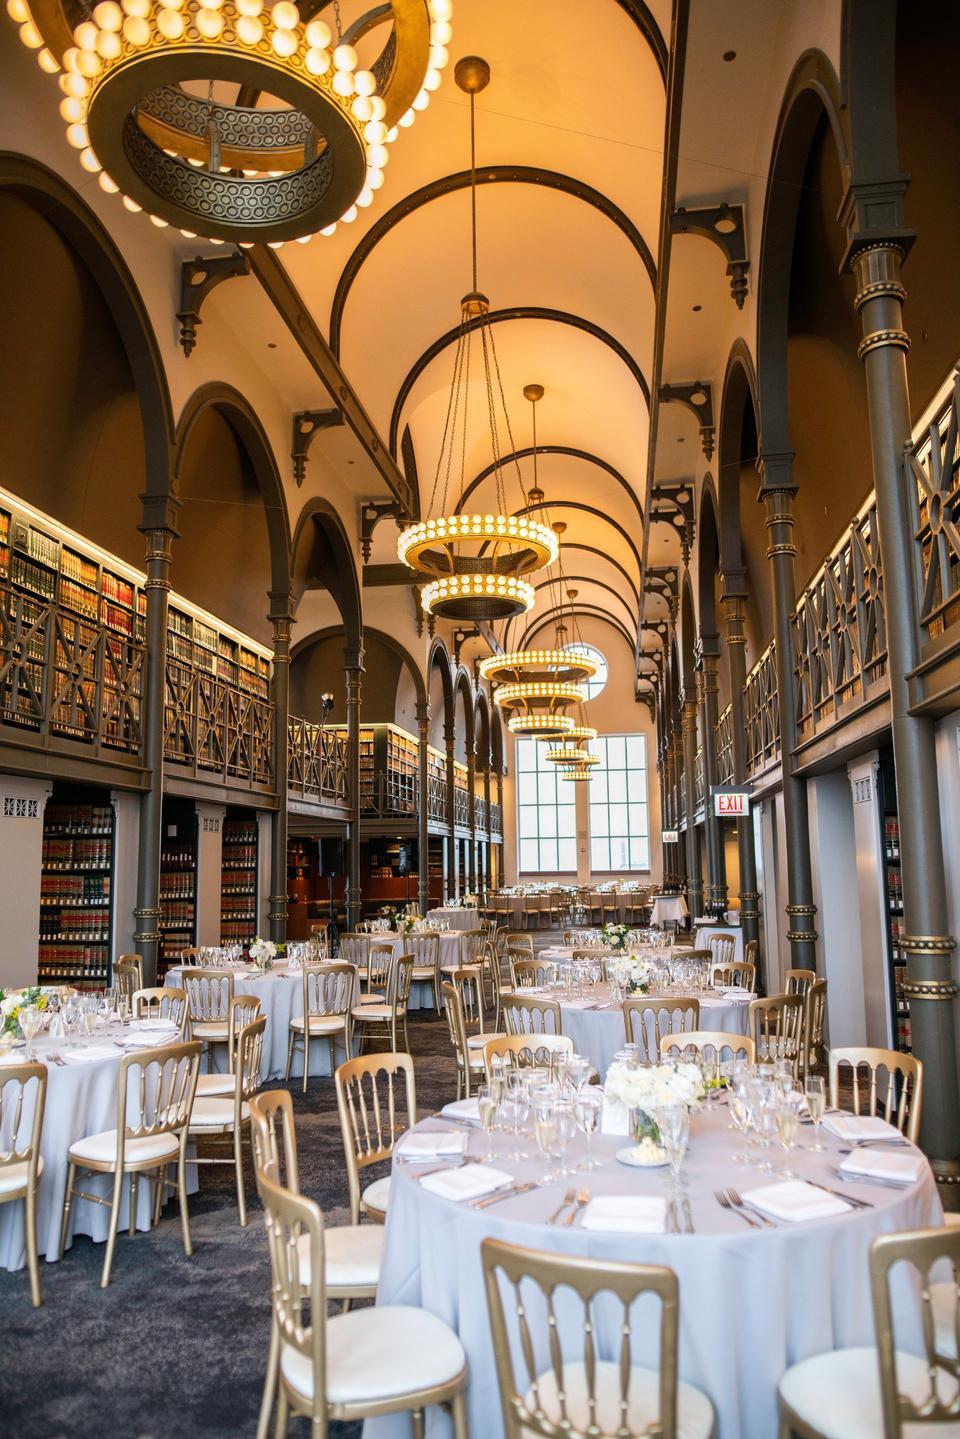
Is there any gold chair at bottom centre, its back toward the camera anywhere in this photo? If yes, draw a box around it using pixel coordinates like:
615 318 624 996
481 1239 717 1439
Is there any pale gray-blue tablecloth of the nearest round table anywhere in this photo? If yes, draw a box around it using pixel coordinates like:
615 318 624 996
364 1104 943 1439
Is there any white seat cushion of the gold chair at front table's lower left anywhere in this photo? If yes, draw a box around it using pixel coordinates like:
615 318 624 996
281 1306 466 1404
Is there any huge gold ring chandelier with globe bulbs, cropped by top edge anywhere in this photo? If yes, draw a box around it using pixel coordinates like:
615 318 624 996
7 0 452 246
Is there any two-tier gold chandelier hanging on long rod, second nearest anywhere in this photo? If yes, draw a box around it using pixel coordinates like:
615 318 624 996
397 55 558 622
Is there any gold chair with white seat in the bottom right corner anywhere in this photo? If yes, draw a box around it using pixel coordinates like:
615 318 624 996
779 1227 960 1439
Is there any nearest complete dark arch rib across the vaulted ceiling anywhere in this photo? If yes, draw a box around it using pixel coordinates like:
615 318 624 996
330 165 656 355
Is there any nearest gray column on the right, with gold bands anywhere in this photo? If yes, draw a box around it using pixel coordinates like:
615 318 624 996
849 227 960 1184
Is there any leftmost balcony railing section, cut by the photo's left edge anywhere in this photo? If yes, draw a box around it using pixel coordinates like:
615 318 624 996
0 586 144 754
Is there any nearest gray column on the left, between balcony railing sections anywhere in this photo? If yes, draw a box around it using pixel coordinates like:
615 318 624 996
134 495 178 986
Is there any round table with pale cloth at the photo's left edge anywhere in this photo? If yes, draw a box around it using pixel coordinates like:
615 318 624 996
0 1026 197 1269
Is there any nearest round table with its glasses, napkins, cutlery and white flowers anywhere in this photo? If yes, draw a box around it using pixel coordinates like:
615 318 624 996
364 1073 943 1439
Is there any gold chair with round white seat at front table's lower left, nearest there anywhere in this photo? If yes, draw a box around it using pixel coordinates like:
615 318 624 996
261 1176 468 1439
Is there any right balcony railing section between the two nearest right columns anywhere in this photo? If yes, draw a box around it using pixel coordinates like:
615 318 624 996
793 495 887 740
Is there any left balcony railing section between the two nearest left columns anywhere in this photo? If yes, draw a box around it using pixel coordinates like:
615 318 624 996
164 658 273 786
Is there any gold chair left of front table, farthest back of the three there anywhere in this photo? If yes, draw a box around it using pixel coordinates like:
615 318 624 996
334 1053 416 1225
